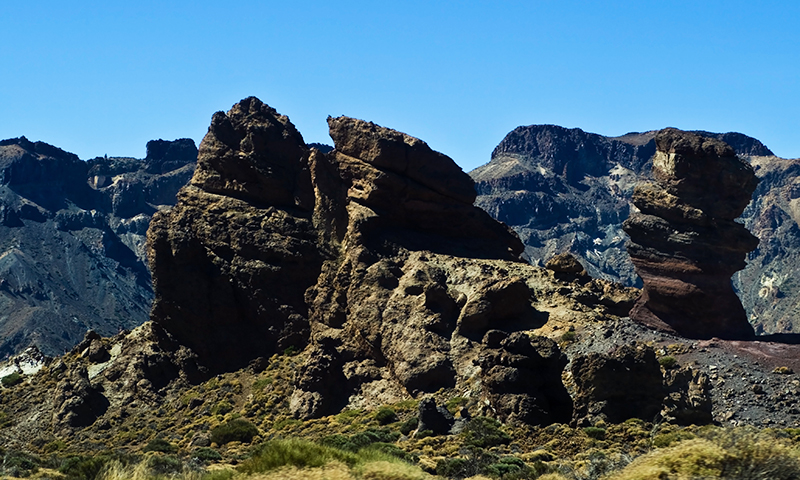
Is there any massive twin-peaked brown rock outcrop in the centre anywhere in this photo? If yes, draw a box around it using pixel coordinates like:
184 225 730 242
148 97 604 423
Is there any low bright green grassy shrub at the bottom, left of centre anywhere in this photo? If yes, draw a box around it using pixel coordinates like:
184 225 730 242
237 439 358 474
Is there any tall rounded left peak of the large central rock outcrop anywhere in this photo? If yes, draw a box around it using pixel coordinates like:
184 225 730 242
147 98 318 370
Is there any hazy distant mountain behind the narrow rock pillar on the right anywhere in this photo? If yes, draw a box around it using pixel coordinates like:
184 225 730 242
470 125 800 334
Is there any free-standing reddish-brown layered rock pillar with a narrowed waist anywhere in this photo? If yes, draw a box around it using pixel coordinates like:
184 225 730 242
623 129 758 339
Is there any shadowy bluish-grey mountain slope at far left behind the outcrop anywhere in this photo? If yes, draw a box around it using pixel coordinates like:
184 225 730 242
0 137 197 357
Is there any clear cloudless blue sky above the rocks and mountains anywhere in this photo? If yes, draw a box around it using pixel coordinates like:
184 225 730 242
0 0 800 170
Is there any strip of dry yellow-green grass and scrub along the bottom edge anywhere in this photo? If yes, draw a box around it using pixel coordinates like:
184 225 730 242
0 427 800 480
